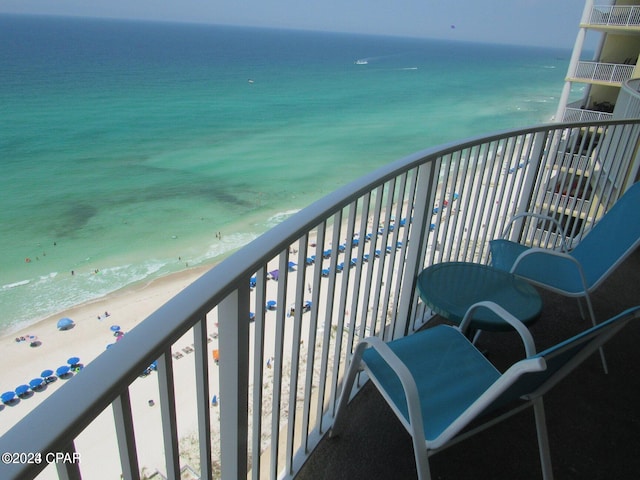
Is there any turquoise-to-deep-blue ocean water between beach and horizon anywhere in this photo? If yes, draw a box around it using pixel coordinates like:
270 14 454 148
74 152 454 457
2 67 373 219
0 12 570 331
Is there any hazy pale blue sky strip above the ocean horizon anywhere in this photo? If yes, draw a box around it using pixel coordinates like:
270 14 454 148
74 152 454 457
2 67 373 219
0 0 592 48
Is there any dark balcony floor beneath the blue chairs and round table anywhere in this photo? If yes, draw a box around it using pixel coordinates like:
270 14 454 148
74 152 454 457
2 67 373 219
297 249 640 480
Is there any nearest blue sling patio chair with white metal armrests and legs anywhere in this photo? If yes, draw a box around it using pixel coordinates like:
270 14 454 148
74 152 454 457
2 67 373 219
331 302 640 480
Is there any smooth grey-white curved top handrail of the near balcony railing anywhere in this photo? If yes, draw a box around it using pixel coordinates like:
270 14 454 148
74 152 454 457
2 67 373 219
0 119 640 476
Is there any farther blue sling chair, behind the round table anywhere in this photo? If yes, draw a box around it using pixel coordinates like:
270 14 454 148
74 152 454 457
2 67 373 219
489 182 640 371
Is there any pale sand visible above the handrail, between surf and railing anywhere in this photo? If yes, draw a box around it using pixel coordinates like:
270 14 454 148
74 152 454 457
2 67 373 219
0 264 215 435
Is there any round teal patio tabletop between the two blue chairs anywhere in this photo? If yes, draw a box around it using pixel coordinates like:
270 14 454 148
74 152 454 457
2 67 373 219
417 262 542 331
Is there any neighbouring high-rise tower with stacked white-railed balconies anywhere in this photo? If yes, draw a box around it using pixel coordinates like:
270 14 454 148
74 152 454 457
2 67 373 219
533 0 640 246
